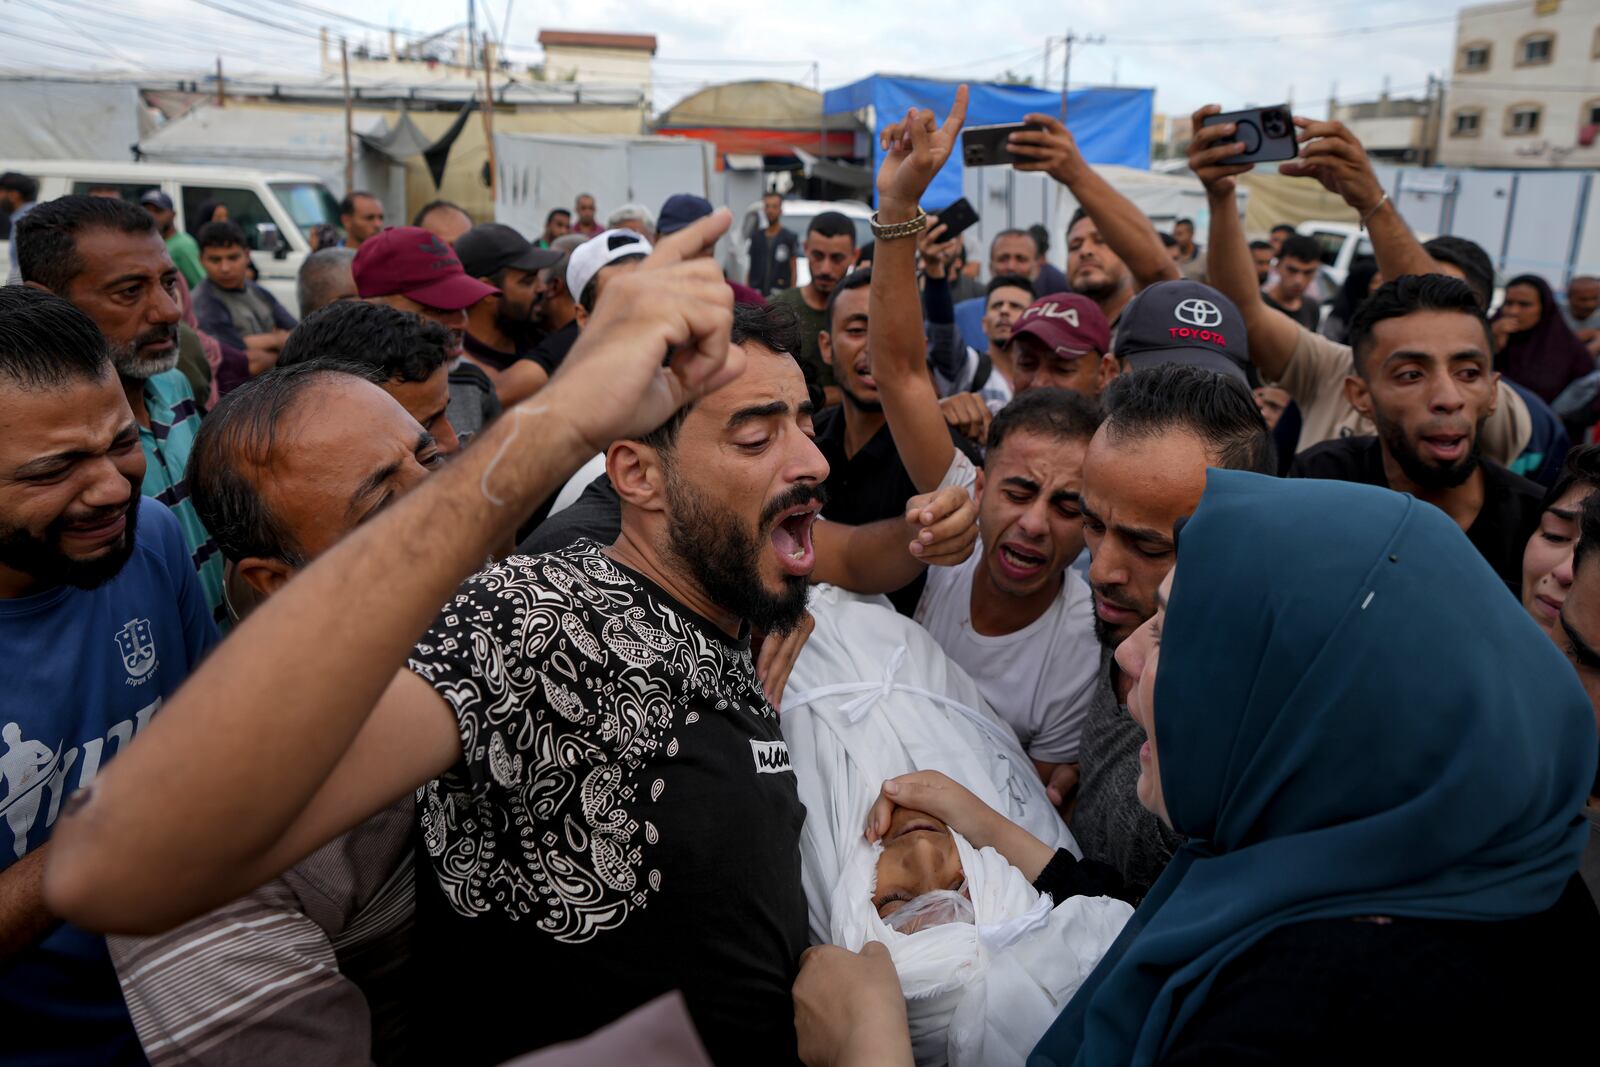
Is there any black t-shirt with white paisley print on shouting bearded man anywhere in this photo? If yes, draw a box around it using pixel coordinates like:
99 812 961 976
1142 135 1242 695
410 541 806 1064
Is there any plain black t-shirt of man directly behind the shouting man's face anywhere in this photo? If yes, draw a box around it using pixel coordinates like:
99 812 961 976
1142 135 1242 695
811 405 984 616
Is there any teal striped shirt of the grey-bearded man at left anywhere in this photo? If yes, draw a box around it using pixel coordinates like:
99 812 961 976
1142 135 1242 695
139 370 229 633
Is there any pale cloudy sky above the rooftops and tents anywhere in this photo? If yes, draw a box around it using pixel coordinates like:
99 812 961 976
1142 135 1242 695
0 0 1462 115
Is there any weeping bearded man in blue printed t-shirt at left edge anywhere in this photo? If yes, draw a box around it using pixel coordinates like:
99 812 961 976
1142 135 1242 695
0 286 218 1067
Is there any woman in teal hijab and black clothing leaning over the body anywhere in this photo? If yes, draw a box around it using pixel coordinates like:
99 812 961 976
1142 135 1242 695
1027 470 1600 1067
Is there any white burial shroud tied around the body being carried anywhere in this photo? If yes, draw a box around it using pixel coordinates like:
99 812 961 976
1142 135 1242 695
782 585 1133 1067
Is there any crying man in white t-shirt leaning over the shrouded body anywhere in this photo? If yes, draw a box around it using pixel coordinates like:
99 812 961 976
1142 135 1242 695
917 389 1101 805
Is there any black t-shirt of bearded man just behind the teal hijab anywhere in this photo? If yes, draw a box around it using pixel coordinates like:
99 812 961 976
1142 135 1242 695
1290 437 1544 597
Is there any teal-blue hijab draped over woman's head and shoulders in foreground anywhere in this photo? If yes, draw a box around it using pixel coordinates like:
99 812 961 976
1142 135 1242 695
1027 470 1595 1067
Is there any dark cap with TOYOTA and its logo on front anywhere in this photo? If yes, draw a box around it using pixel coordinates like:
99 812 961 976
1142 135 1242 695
1112 282 1250 386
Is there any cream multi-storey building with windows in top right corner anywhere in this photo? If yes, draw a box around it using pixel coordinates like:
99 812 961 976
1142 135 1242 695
1438 0 1600 168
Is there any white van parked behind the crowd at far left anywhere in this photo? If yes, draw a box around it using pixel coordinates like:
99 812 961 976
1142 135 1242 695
0 160 339 315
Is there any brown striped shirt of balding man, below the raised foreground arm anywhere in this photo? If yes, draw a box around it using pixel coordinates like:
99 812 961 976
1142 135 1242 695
106 797 416 1067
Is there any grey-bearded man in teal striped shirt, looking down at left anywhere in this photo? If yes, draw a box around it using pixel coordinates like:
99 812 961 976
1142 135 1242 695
14 197 227 625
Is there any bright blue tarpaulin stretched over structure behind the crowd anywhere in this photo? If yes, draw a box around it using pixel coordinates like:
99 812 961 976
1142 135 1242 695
822 74 1155 211
